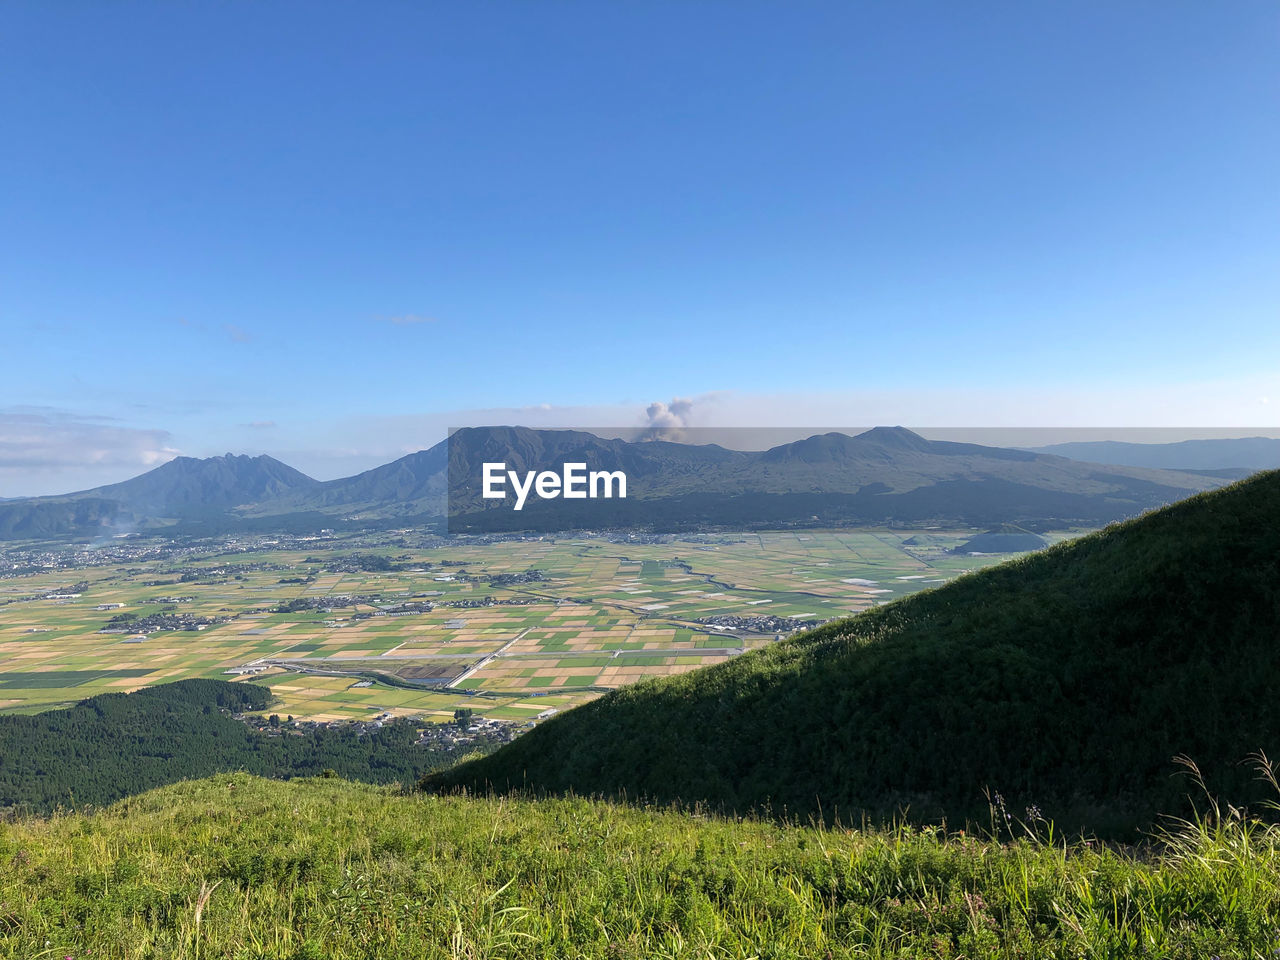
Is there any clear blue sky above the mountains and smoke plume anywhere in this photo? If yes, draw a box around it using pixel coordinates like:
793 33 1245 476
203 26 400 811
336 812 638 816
0 0 1280 497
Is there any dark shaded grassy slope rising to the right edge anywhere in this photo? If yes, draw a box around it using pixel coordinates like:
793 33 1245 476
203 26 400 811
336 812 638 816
429 472 1280 831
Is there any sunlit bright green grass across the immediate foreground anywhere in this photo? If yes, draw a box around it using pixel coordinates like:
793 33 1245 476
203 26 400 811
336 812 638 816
0 774 1280 960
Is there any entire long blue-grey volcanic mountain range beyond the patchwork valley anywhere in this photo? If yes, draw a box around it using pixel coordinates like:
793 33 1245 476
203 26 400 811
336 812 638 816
0 426 1222 539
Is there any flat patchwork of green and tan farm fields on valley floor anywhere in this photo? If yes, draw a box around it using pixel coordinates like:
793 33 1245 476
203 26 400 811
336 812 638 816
0 530 1059 721
